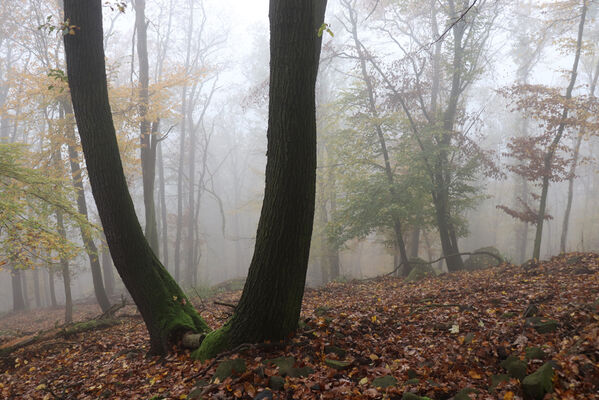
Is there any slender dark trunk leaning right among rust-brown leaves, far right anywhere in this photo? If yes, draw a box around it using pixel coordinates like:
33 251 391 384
532 0 588 260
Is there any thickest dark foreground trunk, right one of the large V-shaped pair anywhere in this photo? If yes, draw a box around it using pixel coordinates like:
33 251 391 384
194 0 326 358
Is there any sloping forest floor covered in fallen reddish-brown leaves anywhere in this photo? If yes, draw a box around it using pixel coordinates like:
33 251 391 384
0 253 599 400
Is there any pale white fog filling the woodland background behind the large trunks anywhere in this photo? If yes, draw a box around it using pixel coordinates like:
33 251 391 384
0 0 599 312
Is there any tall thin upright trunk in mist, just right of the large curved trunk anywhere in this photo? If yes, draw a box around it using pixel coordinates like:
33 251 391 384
134 0 160 256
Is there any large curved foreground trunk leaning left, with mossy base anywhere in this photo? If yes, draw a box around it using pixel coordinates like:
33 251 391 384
64 0 209 354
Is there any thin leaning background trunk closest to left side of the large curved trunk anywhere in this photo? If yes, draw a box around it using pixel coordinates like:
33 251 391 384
62 99 110 312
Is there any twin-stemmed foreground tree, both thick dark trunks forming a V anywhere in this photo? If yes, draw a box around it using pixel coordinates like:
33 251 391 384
64 0 326 358
